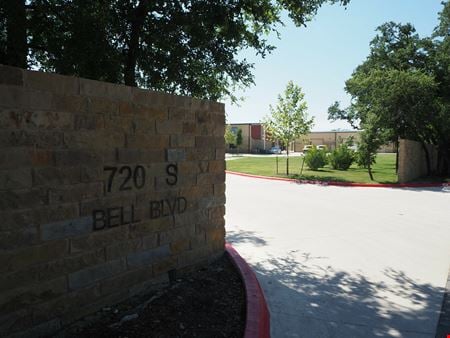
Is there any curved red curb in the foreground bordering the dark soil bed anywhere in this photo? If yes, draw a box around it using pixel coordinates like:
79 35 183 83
225 243 270 338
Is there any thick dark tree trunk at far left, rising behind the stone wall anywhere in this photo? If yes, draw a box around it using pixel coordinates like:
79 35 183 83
5 0 28 68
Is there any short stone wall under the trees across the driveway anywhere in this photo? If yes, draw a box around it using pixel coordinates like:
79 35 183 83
398 140 438 183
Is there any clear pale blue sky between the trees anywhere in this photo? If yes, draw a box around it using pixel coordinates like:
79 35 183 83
225 0 442 131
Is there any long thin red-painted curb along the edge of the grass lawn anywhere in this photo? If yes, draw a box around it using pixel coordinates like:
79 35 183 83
225 170 449 188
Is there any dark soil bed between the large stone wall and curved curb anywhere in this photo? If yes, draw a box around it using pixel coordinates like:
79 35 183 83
58 255 245 338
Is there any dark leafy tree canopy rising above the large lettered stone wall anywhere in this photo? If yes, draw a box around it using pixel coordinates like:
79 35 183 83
0 0 349 100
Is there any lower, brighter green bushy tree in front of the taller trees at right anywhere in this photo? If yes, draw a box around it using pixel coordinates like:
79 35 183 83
346 69 438 174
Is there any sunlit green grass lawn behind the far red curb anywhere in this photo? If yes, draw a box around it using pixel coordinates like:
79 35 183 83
227 154 397 183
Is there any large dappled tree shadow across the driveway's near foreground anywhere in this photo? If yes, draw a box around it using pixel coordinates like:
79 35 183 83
254 252 444 338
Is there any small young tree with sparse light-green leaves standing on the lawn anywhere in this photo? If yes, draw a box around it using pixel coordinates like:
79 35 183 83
262 81 314 175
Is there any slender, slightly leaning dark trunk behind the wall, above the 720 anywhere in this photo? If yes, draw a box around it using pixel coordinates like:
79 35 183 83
124 0 150 87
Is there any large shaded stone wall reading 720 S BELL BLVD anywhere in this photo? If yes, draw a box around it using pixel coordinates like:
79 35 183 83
0 66 225 336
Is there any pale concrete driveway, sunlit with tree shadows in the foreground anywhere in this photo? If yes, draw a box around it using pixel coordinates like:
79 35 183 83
226 174 450 338
